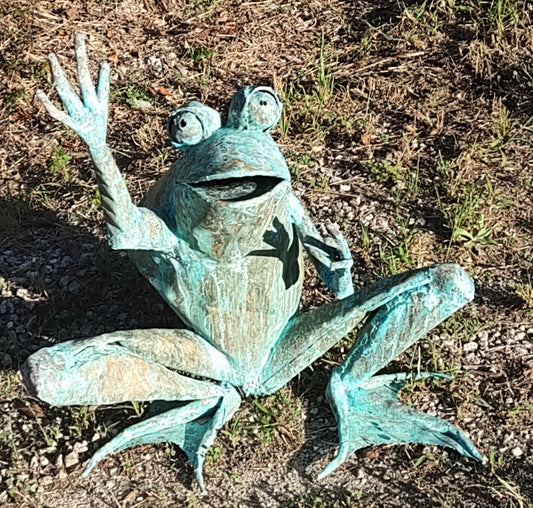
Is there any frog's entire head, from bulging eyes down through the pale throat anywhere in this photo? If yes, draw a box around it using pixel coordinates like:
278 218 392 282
145 87 290 259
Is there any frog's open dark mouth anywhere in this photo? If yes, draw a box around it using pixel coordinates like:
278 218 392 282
189 175 283 203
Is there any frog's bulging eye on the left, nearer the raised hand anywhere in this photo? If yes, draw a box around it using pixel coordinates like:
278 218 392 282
167 102 221 150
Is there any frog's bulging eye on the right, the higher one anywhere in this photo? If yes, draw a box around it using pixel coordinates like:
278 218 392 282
227 86 282 131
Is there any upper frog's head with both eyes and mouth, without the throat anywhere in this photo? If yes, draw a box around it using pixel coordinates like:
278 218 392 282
167 87 290 203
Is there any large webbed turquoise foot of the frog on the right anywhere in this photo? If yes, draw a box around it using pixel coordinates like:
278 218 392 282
319 372 483 478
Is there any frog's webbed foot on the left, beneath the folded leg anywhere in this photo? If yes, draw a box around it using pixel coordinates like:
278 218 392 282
82 387 241 491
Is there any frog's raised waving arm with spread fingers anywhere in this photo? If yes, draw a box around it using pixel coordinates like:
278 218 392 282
37 34 173 250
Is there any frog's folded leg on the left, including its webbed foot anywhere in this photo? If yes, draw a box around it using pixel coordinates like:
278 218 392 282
21 329 240 490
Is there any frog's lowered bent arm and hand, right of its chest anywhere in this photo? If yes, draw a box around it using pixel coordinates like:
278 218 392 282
290 195 353 298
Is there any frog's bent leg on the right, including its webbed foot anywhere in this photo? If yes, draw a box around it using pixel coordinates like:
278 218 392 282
263 265 483 477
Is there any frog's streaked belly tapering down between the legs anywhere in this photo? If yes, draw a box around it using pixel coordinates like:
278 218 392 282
131 250 303 383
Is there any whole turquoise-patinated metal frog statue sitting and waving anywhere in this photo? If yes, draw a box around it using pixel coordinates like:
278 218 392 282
21 35 482 489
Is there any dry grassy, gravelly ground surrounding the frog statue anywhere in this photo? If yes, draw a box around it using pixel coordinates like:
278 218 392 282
0 0 533 508
